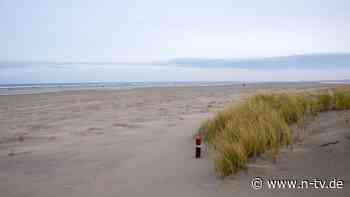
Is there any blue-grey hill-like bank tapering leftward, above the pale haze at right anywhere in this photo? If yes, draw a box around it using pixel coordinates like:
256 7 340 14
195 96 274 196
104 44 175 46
170 53 350 69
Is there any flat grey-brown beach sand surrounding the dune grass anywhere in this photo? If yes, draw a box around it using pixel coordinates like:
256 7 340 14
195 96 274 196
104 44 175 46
0 85 350 197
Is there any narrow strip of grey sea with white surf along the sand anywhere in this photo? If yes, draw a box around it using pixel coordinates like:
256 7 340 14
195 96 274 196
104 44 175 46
0 81 350 95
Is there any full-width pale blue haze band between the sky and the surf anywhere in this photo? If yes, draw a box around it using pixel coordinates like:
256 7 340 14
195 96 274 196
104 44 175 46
0 55 350 84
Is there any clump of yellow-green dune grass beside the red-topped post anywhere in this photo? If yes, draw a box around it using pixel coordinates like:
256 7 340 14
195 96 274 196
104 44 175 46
199 87 350 177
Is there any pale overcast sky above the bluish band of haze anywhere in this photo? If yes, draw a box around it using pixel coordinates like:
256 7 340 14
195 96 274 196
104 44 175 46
0 0 350 62
